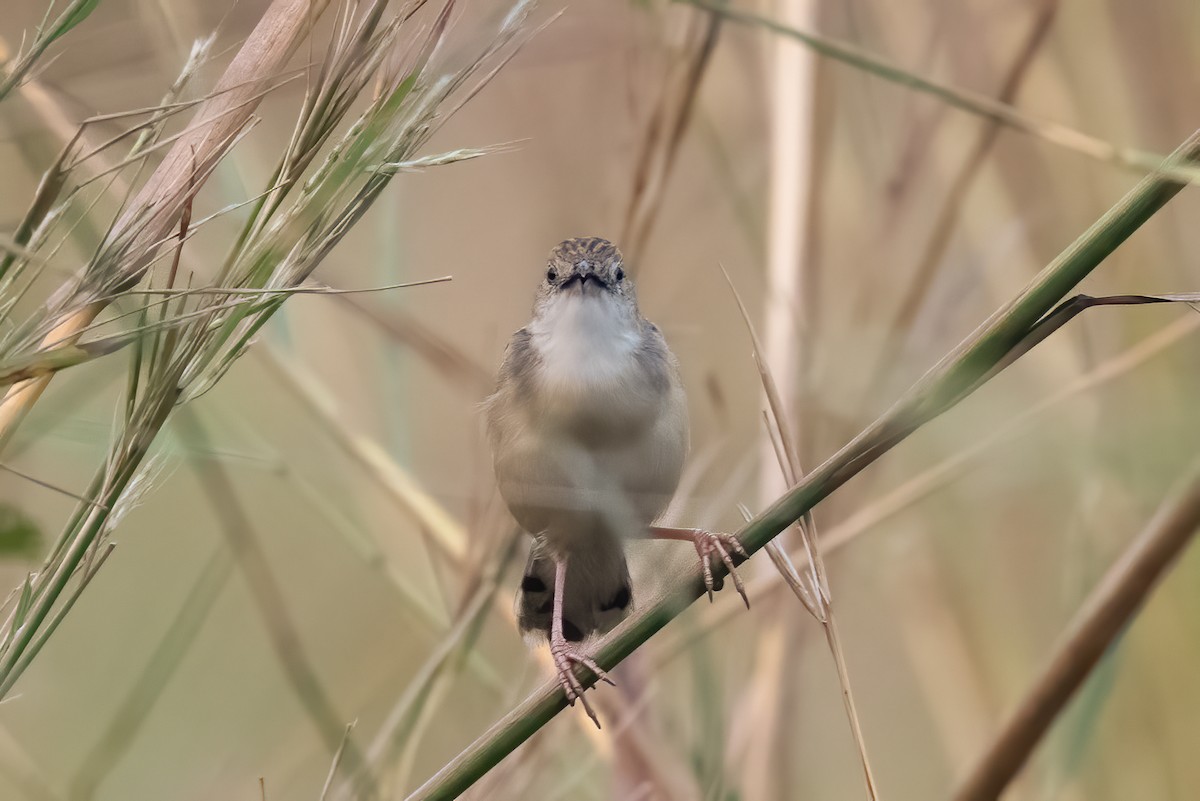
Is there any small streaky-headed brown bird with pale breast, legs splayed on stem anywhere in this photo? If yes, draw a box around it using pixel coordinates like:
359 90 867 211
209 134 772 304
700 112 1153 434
485 237 750 725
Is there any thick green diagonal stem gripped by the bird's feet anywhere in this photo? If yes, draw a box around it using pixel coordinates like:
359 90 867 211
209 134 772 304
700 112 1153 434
408 131 1200 801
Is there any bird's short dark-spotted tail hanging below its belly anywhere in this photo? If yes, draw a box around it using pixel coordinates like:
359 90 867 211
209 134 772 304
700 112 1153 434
516 542 634 643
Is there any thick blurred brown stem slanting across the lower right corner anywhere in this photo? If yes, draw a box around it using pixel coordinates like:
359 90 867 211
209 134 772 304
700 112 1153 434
952 460 1200 801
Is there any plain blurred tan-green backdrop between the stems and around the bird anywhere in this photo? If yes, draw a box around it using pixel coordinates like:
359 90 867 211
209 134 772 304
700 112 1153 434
0 0 1200 800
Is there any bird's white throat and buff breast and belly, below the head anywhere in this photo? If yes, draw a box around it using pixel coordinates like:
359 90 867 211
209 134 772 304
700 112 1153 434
493 296 688 544
